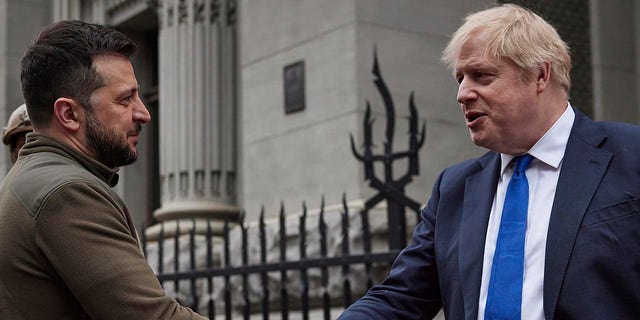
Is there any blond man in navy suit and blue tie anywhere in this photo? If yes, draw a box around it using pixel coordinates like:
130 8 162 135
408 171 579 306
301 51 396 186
341 5 640 320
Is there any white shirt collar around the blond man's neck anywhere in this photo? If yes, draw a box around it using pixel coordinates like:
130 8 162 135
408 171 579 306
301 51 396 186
500 103 576 176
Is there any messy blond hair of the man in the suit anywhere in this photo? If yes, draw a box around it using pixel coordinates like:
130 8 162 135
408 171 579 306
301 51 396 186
442 4 571 93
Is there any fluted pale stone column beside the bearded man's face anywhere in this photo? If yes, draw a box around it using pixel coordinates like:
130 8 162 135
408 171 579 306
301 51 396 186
154 0 239 224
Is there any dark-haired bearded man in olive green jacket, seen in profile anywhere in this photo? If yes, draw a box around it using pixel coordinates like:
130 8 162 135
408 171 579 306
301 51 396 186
0 21 203 319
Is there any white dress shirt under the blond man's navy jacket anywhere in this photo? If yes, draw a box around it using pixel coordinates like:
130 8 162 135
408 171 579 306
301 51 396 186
478 104 575 320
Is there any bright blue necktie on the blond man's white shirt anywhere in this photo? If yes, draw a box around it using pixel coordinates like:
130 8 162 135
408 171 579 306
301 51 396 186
484 154 533 320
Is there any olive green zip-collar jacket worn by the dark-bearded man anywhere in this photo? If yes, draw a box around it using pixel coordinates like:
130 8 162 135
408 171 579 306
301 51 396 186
0 133 204 320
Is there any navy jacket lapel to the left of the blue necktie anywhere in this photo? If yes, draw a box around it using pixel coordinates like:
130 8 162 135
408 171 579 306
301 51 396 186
458 153 500 319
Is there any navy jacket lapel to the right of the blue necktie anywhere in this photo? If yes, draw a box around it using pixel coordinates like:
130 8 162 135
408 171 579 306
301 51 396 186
544 112 612 319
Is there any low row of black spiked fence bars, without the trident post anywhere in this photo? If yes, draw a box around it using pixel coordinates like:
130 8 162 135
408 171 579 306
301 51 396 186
142 197 399 319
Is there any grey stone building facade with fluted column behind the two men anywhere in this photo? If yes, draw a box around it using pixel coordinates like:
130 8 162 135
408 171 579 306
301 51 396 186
0 0 640 240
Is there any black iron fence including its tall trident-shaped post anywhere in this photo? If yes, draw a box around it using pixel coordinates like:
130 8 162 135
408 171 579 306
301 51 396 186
142 51 426 320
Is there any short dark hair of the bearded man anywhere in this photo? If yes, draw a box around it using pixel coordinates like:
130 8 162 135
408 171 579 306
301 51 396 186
20 20 137 126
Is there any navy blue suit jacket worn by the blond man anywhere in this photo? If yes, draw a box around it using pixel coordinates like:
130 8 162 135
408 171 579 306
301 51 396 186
340 111 640 319
